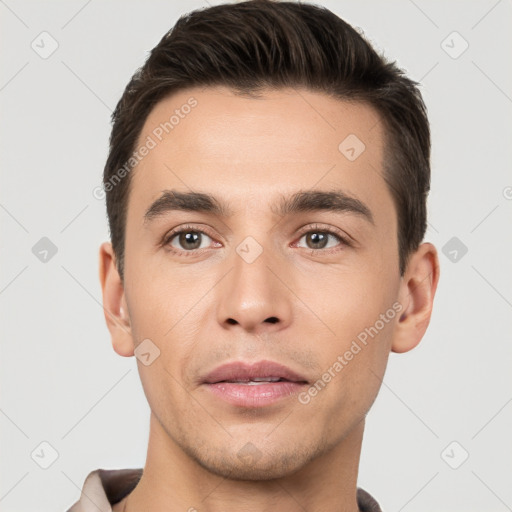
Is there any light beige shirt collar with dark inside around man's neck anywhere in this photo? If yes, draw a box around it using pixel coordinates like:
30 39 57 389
67 468 382 512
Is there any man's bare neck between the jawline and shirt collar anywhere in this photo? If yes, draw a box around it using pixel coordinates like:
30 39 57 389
118 414 364 512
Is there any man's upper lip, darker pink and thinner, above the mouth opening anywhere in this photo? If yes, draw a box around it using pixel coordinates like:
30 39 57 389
203 361 307 384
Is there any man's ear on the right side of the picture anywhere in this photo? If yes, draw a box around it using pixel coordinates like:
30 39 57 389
391 243 439 352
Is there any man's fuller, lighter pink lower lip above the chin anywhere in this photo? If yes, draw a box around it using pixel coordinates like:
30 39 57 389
205 381 307 407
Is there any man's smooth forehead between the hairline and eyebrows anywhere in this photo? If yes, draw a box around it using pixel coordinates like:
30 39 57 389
128 87 393 224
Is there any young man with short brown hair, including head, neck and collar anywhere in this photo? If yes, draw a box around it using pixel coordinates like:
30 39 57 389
70 0 439 512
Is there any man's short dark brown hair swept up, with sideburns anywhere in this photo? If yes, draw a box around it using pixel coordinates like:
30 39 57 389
103 0 430 278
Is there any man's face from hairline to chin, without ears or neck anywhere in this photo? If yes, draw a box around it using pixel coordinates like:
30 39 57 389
116 87 402 479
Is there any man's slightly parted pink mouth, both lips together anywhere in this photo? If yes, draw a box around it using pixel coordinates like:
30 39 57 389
203 361 308 408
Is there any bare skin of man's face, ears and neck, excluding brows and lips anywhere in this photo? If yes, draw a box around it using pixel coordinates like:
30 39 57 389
100 87 439 512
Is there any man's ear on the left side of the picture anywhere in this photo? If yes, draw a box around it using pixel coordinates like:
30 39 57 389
99 242 134 357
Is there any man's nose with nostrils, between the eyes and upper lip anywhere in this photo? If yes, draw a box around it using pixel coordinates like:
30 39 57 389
216 242 293 334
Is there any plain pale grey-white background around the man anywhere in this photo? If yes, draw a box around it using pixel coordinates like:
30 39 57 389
0 0 512 512
